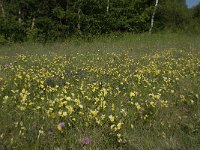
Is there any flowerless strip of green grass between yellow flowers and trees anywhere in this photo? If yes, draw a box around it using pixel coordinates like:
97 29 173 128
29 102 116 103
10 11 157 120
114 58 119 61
0 33 200 56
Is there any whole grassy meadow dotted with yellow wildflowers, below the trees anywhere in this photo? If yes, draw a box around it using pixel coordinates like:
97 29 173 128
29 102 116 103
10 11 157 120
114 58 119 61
0 34 200 150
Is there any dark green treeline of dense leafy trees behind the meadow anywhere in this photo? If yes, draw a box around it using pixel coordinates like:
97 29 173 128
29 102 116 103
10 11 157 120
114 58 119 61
0 0 200 42
